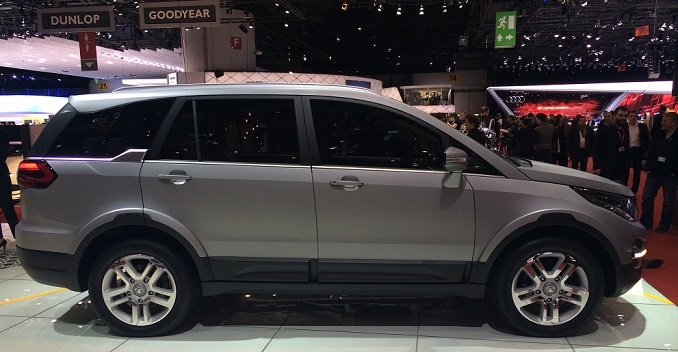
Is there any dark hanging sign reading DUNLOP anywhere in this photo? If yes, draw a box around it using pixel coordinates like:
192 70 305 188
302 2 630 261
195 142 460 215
38 6 115 33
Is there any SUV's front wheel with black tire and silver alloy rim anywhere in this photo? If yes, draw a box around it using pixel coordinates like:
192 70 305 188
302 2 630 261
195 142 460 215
489 238 605 337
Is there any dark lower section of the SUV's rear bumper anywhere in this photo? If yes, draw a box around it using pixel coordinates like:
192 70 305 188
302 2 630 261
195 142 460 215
17 246 86 292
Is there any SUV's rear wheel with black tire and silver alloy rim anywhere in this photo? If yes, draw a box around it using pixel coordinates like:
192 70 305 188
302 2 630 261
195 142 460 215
88 239 200 336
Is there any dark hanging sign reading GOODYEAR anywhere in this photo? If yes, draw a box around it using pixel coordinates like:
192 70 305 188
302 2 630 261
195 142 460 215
139 0 221 28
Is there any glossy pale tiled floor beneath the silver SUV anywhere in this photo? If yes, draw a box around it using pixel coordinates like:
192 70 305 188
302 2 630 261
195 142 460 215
0 246 678 352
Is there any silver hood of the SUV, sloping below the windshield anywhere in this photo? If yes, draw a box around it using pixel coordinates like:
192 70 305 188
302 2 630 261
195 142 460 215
518 161 633 197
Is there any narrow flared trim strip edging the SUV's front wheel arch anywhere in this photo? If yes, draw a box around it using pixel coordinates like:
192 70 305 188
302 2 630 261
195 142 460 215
469 214 621 283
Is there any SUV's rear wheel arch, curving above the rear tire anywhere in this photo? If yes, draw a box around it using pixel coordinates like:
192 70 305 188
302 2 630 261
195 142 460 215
75 213 213 290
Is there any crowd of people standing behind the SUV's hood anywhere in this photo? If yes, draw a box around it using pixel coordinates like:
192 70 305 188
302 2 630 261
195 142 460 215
447 105 678 266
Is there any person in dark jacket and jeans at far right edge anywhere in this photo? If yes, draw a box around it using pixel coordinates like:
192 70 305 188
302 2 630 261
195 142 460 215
640 112 678 232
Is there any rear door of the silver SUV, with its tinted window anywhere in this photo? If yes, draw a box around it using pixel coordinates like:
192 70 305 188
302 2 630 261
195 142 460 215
141 96 317 282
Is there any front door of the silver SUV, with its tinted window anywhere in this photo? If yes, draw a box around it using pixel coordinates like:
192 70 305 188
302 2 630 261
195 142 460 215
306 98 475 283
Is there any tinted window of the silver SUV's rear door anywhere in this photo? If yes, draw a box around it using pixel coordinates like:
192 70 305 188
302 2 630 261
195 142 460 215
159 98 300 164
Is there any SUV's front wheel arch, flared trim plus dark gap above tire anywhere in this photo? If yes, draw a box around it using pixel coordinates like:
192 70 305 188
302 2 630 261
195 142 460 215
470 213 621 297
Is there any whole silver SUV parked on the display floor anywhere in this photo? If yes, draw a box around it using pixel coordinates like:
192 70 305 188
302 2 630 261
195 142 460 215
17 84 645 336
